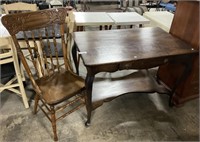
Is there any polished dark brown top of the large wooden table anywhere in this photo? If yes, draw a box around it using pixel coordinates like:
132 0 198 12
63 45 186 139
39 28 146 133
73 27 198 67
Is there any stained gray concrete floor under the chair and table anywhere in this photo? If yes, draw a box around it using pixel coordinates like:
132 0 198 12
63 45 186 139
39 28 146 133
0 3 199 142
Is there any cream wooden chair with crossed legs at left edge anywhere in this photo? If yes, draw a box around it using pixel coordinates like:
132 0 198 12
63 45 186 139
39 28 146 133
0 37 29 108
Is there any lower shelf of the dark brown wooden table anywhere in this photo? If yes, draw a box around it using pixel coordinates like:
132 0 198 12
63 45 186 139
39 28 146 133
92 70 169 109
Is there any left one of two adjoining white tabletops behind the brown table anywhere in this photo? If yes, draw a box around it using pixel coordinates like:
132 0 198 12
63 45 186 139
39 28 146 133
74 12 114 26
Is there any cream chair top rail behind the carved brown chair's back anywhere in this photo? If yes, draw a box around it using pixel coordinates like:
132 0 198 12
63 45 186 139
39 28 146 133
3 2 38 14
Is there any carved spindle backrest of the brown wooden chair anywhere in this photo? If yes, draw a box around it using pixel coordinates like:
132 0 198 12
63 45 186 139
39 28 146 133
2 8 71 93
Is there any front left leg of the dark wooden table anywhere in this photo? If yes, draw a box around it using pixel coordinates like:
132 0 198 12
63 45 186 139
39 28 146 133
85 73 94 126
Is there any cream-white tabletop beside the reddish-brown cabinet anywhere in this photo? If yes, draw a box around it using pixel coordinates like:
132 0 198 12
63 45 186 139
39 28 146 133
143 11 174 32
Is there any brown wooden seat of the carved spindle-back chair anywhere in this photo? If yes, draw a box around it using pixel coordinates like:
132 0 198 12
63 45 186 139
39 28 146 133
36 71 85 105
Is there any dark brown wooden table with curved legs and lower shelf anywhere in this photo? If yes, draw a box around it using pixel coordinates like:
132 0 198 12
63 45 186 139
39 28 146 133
72 27 198 125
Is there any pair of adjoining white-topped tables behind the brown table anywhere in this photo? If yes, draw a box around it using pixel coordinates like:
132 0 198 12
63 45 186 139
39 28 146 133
74 12 149 31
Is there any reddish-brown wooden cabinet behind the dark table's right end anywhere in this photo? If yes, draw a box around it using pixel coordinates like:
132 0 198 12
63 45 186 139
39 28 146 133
158 1 200 105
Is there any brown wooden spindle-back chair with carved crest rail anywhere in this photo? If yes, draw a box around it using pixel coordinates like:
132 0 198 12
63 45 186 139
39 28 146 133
2 8 85 141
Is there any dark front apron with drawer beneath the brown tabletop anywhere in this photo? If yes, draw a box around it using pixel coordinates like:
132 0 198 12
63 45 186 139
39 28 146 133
86 54 192 75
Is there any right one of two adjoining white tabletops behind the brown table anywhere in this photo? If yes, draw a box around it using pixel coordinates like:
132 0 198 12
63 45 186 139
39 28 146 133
108 12 150 25
